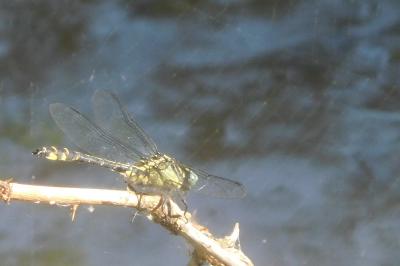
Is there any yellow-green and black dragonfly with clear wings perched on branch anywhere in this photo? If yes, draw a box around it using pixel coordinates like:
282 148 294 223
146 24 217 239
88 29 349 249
33 90 246 212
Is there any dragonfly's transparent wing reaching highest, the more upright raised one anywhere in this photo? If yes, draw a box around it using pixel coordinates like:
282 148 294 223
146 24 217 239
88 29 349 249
92 91 157 157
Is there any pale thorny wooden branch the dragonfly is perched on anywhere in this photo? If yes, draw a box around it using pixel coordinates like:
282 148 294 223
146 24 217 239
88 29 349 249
0 180 253 265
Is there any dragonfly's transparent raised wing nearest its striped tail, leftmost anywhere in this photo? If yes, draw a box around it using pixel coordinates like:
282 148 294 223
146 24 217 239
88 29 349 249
49 103 142 163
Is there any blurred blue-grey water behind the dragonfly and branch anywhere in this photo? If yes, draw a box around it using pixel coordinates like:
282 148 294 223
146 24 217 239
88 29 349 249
0 0 400 266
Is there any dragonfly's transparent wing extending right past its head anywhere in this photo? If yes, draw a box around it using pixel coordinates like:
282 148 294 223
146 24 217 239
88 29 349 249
189 168 246 198
